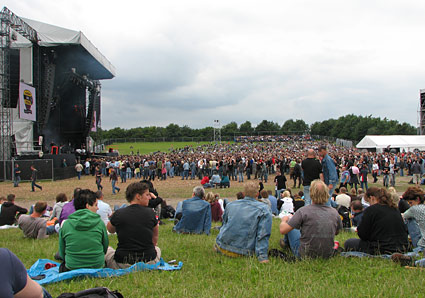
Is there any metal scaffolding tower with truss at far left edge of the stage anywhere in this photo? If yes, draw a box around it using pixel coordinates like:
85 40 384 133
0 7 38 160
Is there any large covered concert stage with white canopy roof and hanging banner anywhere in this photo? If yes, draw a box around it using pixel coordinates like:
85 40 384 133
0 7 115 160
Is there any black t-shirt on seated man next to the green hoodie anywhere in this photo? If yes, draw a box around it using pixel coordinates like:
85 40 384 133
111 204 158 264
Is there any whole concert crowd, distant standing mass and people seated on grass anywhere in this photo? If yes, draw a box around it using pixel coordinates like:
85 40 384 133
0 138 425 296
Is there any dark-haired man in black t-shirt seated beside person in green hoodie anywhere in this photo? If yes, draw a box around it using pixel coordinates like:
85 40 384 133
105 182 161 269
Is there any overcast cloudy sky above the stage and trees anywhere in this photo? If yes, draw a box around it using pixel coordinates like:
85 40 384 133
3 0 425 129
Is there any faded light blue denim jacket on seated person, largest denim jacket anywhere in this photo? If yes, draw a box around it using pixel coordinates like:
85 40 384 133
216 197 272 261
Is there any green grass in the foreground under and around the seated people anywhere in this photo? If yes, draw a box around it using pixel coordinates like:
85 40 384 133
0 219 425 297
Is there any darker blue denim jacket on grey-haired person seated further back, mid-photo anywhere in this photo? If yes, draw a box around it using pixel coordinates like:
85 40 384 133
173 197 211 235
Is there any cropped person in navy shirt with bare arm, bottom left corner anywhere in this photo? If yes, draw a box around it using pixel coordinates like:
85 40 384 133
0 248 52 298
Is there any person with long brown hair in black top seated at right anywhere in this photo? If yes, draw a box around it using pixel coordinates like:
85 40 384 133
344 187 409 255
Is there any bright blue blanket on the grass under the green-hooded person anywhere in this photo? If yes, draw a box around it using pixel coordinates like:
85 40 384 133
27 258 183 285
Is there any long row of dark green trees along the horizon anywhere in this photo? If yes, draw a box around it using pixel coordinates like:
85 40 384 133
95 114 417 141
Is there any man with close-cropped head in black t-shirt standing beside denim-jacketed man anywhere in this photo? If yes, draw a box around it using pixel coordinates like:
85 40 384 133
301 149 324 206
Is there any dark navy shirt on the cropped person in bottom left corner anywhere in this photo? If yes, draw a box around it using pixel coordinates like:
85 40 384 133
0 248 27 298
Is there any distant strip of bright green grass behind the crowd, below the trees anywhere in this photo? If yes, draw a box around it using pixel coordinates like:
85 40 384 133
106 142 227 155
